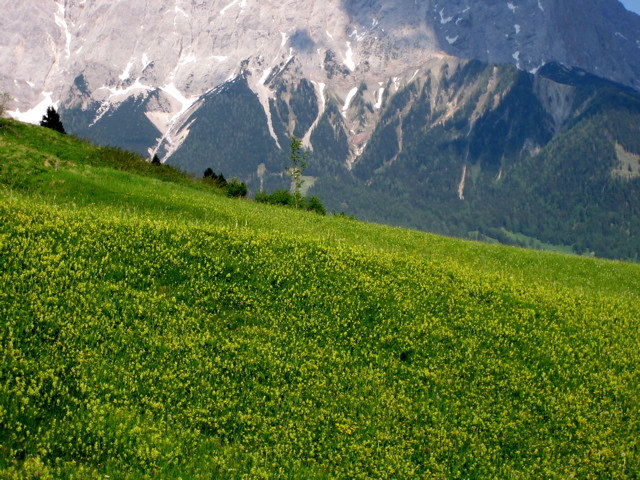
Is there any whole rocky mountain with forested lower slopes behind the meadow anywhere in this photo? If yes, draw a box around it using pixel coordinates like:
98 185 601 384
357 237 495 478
0 0 640 257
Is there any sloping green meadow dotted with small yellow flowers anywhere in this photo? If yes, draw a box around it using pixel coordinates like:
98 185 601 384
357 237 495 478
0 122 640 479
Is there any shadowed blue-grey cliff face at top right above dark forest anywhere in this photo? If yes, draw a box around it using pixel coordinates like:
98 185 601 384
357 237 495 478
432 0 640 89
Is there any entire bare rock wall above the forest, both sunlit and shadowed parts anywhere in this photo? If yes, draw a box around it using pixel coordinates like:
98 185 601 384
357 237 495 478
5 0 640 150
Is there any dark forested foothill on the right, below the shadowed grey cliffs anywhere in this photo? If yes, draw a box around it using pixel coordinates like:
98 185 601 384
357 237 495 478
312 61 640 260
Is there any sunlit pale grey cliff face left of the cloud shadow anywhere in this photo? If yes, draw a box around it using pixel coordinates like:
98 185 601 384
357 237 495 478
0 0 436 125
